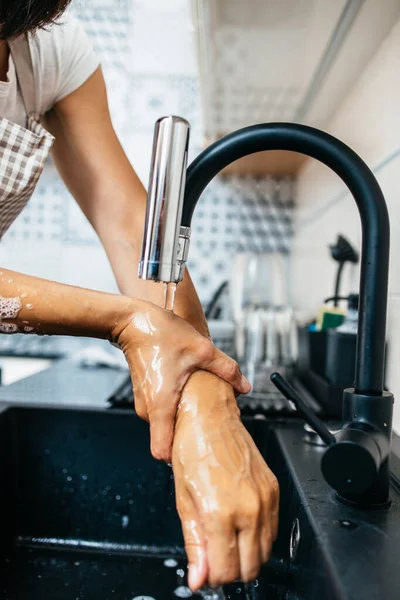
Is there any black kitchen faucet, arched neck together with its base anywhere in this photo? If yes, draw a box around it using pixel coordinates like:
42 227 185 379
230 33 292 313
141 123 393 507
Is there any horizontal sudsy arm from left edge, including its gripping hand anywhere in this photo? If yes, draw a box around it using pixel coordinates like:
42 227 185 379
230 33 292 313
0 269 250 454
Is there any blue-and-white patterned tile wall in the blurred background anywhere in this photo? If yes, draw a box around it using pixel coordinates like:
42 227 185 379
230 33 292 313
0 0 293 308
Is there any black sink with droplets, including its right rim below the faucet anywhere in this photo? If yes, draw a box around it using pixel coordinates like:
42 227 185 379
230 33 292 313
0 404 400 600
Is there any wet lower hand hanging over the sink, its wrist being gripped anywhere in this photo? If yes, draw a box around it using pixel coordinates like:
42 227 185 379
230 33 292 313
172 372 279 590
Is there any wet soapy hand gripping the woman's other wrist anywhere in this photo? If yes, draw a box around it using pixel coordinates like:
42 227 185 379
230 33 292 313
113 300 251 462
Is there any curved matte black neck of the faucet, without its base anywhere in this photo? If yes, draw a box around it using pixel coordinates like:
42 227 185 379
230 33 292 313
182 123 389 396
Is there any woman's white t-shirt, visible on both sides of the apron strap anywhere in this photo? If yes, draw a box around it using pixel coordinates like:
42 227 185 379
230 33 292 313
0 13 99 127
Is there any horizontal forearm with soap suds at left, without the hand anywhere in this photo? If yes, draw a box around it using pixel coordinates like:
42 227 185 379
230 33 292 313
0 269 134 339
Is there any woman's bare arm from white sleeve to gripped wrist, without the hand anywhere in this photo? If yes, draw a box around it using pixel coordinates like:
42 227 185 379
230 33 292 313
45 69 208 335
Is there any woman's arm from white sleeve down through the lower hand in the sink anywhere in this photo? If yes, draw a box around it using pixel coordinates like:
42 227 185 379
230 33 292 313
41 70 278 589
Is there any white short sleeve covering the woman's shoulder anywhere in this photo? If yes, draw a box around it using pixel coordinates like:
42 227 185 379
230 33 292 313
30 12 99 113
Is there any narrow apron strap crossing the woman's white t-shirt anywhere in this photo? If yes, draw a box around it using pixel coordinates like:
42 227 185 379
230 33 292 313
9 34 37 116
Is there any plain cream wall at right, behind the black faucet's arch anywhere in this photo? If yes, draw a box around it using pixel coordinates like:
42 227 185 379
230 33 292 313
292 22 400 431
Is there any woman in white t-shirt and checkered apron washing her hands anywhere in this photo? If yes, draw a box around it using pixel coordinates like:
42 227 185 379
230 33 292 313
0 0 279 589
